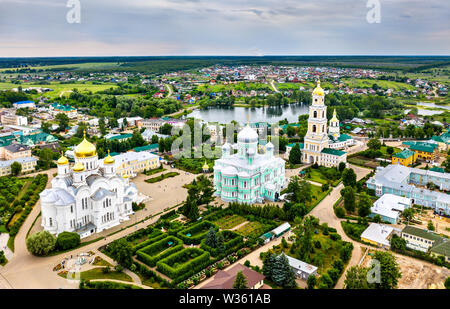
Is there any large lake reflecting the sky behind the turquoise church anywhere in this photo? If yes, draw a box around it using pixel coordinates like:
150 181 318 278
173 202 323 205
188 104 309 123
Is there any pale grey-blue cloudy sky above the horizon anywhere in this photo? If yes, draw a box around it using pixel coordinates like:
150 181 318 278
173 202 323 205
0 0 450 57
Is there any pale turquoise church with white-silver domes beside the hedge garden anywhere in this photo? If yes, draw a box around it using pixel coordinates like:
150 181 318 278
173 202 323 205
214 124 285 204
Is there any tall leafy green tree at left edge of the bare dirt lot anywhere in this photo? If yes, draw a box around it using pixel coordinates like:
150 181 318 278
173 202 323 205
374 251 402 290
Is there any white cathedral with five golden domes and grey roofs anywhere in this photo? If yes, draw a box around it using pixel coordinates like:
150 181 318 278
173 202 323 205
40 133 138 238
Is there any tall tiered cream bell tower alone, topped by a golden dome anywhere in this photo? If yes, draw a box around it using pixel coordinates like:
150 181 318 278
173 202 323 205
303 80 328 165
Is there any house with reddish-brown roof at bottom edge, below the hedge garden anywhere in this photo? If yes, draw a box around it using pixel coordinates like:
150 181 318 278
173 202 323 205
201 264 265 290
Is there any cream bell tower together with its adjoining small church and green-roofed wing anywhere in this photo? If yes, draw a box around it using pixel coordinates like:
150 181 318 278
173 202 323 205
302 81 348 167
